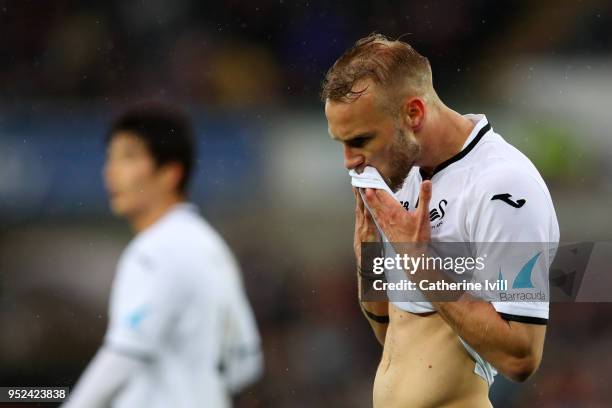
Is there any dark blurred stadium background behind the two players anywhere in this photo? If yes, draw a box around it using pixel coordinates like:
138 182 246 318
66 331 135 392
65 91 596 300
0 0 612 407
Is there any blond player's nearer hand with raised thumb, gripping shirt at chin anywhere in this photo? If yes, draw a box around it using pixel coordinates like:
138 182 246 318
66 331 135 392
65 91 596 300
365 180 431 243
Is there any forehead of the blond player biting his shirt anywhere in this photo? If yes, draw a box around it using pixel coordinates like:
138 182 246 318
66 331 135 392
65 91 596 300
325 83 384 140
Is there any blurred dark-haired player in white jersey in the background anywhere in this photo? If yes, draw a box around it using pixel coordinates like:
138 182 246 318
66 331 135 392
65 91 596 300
66 104 262 408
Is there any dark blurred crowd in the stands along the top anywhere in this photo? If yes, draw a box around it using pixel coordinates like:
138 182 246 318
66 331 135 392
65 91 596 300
0 0 612 109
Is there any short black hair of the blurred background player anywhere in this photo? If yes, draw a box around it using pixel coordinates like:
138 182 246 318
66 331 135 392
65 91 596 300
106 103 196 194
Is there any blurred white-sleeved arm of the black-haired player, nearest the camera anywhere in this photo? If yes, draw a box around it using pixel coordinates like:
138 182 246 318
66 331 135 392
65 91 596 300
66 245 180 408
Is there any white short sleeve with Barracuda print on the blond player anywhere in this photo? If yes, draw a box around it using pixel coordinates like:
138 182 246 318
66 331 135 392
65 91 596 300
467 167 559 324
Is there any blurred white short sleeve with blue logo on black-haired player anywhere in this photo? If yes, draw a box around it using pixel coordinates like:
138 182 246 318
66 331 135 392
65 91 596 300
105 245 182 357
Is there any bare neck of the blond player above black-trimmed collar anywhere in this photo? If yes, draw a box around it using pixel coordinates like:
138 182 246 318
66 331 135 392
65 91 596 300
420 105 474 172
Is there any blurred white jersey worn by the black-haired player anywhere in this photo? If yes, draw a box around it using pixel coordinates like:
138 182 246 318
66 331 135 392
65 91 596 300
105 203 262 408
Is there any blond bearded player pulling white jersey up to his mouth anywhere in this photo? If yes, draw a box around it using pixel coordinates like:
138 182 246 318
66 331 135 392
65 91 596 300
322 34 559 408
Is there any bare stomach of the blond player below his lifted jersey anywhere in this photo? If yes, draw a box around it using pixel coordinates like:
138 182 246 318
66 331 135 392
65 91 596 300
374 304 491 408
